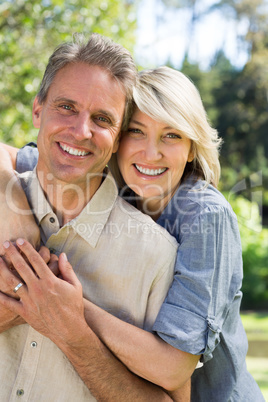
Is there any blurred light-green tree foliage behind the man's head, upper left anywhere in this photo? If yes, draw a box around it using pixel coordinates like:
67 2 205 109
0 0 136 146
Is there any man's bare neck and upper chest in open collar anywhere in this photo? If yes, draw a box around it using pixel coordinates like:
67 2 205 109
37 171 103 226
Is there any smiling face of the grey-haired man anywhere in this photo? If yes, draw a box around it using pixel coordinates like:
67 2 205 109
33 63 125 187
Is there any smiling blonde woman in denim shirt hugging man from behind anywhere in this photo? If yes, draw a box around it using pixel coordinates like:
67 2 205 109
0 67 264 402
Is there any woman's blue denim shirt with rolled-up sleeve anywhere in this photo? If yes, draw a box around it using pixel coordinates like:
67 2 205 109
17 146 264 402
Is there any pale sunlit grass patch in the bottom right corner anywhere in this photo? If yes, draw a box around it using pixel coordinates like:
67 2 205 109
241 312 268 402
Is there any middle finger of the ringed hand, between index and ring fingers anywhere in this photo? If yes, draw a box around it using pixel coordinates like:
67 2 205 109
3 241 38 284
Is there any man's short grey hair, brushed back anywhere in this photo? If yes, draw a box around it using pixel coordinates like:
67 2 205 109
37 33 137 129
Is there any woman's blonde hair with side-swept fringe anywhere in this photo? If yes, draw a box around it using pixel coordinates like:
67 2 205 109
109 67 222 186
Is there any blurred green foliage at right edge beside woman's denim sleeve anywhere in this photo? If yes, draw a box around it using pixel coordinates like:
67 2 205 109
227 196 268 310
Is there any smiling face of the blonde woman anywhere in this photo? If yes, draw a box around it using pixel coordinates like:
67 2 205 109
117 109 193 213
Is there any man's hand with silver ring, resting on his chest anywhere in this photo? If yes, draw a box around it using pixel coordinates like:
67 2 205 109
0 239 86 345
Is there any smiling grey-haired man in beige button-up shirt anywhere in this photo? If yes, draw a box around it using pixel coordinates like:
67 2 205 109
0 35 180 402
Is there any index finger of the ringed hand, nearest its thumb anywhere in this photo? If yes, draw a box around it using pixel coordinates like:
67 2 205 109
16 239 52 282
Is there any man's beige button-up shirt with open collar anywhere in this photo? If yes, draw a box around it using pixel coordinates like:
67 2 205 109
0 172 177 402
